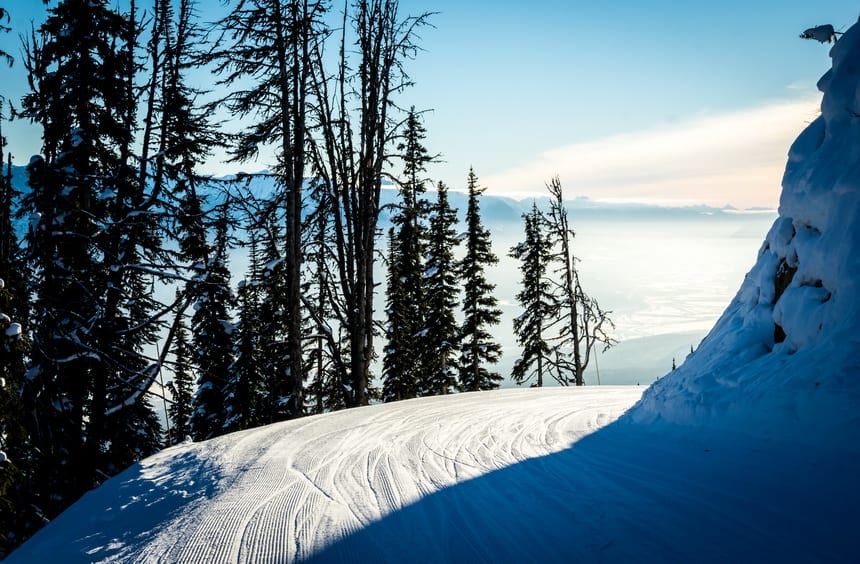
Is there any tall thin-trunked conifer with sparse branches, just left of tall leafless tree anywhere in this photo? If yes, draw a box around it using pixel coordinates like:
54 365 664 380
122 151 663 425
213 0 326 419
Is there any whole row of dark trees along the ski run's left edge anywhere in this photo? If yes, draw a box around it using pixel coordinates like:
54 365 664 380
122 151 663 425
0 0 611 555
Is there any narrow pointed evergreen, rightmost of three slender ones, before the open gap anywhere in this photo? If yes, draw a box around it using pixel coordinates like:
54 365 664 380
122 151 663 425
460 170 502 391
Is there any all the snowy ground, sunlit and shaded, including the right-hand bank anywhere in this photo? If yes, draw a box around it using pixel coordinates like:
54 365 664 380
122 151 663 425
8 17 860 563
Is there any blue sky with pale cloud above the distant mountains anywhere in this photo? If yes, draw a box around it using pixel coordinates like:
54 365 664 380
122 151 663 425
0 0 860 208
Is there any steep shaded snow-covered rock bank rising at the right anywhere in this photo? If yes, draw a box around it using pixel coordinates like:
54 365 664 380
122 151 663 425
630 24 860 449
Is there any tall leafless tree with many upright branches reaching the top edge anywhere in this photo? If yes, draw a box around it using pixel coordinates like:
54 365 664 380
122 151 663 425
312 0 429 407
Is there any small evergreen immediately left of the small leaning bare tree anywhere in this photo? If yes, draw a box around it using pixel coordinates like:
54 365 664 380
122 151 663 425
510 203 558 387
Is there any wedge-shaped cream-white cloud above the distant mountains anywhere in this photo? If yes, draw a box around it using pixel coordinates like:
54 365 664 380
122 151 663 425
483 95 820 208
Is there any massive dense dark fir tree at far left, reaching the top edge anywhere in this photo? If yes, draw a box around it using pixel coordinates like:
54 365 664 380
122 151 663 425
22 0 161 518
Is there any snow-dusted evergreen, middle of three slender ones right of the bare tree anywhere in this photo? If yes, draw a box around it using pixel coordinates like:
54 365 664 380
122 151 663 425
421 182 460 395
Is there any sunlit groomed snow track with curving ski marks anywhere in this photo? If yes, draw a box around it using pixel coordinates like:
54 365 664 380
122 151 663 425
65 387 642 564
